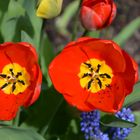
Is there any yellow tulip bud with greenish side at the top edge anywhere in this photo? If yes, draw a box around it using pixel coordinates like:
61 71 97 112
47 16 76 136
36 0 63 19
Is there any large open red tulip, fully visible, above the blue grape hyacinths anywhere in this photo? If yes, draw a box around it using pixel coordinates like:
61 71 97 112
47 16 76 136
49 38 138 112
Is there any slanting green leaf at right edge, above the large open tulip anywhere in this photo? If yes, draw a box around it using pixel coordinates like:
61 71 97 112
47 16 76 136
113 17 140 45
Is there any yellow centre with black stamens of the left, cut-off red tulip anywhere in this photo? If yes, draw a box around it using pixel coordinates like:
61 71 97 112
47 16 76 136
0 63 30 95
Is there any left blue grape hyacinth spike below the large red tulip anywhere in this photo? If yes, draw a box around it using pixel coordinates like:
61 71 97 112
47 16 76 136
80 110 109 140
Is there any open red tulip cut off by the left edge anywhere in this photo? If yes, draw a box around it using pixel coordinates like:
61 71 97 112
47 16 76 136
0 42 42 120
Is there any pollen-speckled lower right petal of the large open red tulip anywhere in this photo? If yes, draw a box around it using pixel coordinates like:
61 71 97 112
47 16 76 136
87 76 125 113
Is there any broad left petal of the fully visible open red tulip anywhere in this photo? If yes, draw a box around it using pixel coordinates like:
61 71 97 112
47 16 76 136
49 43 87 96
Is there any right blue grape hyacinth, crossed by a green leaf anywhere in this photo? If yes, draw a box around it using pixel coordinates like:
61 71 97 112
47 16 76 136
110 108 135 140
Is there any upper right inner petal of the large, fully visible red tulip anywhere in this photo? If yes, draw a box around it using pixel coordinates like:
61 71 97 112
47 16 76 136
77 39 125 72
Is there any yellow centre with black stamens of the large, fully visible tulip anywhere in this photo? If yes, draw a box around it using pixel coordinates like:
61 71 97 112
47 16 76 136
78 59 113 93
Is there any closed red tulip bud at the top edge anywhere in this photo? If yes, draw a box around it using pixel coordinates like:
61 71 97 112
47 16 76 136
80 0 116 30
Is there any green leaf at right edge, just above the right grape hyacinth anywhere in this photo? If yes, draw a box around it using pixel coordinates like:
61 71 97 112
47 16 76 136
124 82 140 106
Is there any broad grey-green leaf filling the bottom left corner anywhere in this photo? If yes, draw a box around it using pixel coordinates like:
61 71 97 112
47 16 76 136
0 127 45 140
